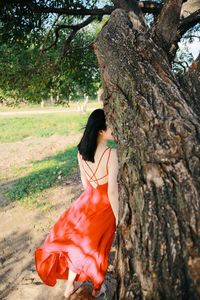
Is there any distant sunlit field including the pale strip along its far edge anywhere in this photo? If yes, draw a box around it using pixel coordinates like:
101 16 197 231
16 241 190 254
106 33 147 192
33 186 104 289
0 101 102 143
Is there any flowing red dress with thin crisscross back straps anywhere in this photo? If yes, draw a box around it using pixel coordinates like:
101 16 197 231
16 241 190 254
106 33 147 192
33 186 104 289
35 148 116 289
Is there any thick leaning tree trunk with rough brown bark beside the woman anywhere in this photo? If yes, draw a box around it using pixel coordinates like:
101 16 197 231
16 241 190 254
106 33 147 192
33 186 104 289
95 9 200 300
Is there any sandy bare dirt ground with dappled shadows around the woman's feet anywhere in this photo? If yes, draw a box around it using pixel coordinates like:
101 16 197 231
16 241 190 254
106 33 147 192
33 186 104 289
0 135 116 300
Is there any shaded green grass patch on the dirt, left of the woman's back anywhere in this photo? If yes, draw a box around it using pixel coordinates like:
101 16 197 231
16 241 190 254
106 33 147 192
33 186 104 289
0 146 78 207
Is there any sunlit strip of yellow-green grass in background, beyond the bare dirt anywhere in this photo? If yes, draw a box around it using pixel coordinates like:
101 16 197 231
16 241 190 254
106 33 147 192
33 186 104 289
0 113 89 143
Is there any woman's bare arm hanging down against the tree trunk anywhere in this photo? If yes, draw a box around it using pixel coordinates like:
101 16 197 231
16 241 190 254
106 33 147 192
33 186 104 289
108 149 119 226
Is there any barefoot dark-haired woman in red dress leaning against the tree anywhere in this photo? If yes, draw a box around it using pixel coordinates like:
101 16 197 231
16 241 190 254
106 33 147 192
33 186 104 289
35 109 118 298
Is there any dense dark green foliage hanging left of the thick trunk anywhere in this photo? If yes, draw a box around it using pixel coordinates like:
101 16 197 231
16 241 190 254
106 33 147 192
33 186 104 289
0 5 99 105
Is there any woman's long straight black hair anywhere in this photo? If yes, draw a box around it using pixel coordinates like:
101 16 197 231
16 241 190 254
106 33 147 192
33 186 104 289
77 109 107 162
